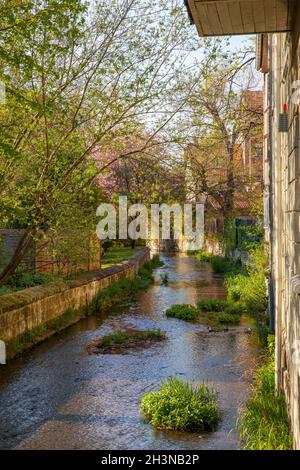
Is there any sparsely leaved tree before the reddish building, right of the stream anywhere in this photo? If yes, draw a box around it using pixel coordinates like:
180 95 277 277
185 41 262 219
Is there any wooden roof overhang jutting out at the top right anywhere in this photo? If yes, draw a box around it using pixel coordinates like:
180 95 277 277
185 0 298 36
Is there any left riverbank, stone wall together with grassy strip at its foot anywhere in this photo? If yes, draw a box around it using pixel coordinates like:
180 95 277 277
0 248 150 359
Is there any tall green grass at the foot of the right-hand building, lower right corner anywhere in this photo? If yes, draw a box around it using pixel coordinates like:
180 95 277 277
238 337 292 450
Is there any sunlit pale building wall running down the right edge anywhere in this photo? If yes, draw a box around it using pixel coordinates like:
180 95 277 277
264 16 300 449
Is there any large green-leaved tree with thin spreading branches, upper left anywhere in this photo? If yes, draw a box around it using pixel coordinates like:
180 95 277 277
0 0 198 285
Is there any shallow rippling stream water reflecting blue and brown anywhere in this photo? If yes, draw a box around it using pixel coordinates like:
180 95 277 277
0 256 259 450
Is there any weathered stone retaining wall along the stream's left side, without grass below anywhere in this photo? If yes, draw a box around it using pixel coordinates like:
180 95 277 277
0 248 150 342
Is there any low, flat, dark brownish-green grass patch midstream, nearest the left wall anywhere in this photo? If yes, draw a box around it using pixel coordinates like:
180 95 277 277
97 329 166 349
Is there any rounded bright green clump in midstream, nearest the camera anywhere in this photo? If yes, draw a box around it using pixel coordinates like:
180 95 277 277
140 378 221 431
